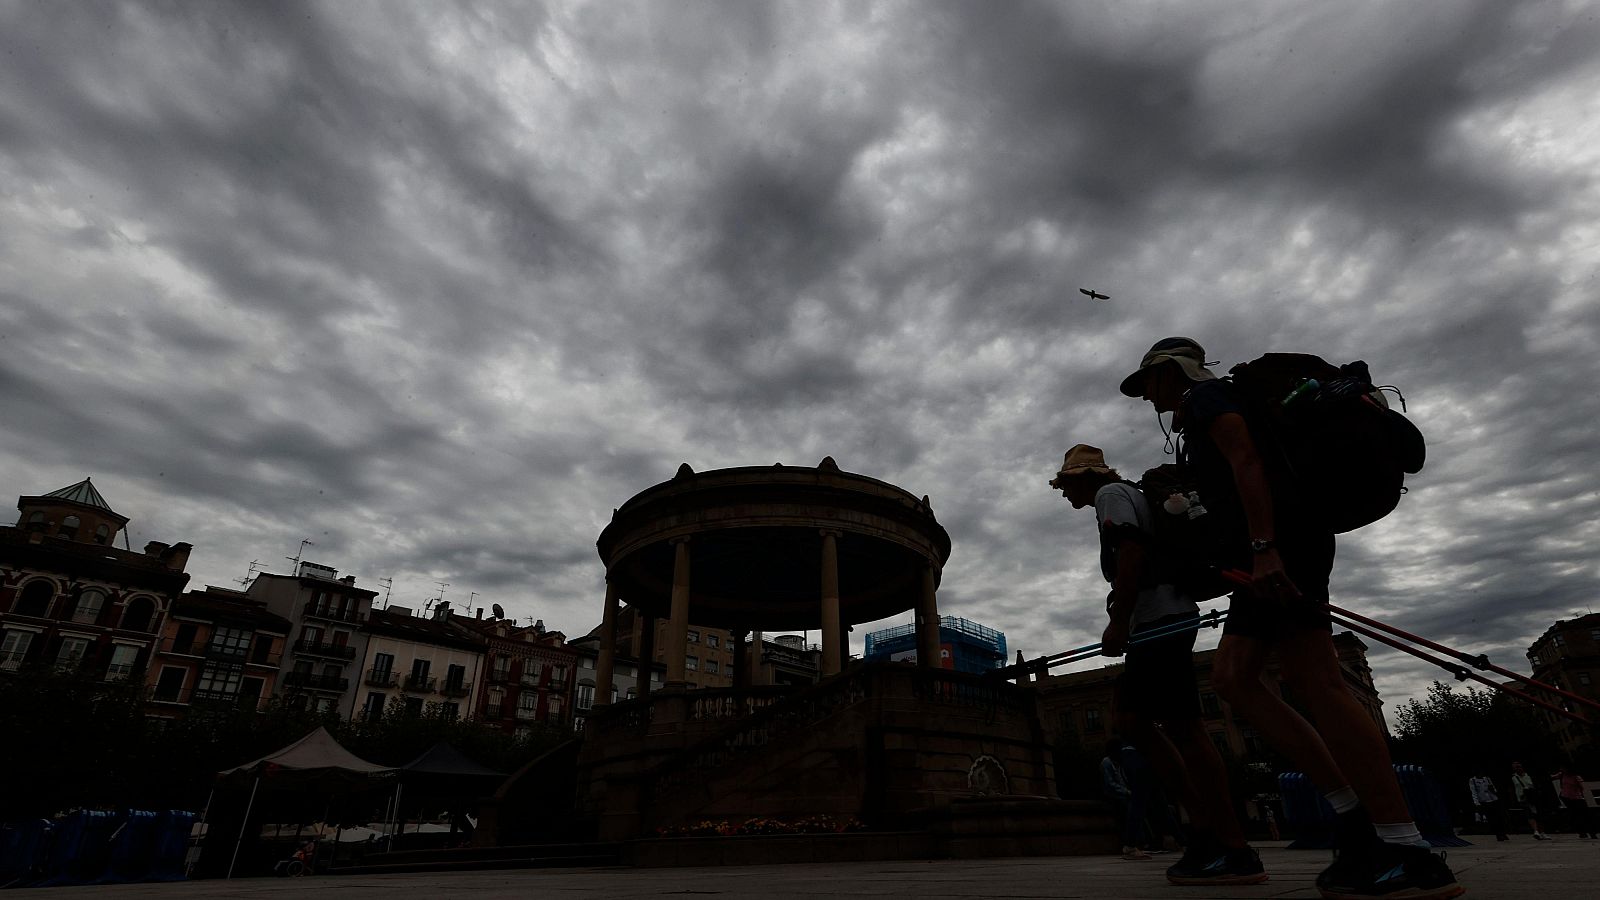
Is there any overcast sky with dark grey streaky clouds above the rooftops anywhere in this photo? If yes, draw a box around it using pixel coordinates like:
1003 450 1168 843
0 0 1600 709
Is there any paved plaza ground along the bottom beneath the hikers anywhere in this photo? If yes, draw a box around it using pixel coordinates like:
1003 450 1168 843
6 836 1600 900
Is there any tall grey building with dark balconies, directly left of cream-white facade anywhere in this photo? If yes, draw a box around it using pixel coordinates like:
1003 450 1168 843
245 562 378 716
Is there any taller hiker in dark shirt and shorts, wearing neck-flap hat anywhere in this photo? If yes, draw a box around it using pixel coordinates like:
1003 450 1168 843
1122 338 1462 900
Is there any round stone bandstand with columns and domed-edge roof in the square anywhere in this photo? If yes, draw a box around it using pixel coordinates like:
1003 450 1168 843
578 458 1099 855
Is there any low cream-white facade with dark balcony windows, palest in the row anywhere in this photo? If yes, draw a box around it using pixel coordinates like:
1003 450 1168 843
355 604 488 719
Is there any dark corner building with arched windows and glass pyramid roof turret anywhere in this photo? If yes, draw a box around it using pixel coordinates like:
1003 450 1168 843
0 479 190 682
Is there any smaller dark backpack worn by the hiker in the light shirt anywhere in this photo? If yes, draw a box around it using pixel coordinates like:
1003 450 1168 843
1139 463 1234 602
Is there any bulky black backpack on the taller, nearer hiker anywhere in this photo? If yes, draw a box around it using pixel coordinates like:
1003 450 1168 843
1229 354 1426 533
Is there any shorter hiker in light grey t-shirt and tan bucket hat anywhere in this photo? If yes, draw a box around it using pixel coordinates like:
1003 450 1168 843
1050 444 1267 884
